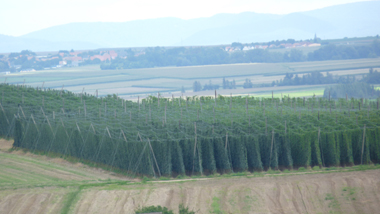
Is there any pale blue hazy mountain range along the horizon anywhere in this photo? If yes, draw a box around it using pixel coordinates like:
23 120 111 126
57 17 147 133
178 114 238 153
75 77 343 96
0 1 380 53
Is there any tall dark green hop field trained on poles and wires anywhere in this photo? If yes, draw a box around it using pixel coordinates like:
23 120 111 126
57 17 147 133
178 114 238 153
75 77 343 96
0 84 380 176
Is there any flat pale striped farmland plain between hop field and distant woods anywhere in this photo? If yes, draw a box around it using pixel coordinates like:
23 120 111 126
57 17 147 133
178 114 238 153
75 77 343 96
0 58 380 99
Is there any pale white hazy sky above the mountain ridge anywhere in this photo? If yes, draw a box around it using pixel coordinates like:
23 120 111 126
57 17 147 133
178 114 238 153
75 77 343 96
0 0 372 36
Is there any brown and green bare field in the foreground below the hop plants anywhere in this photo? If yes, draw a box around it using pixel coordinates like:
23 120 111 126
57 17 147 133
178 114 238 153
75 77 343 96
0 140 380 214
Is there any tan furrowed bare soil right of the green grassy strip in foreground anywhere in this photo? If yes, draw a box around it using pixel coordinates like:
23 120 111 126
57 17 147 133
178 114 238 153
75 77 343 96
75 170 380 213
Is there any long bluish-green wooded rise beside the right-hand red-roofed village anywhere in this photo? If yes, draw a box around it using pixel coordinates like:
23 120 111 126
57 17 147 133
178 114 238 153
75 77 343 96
101 40 380 69
